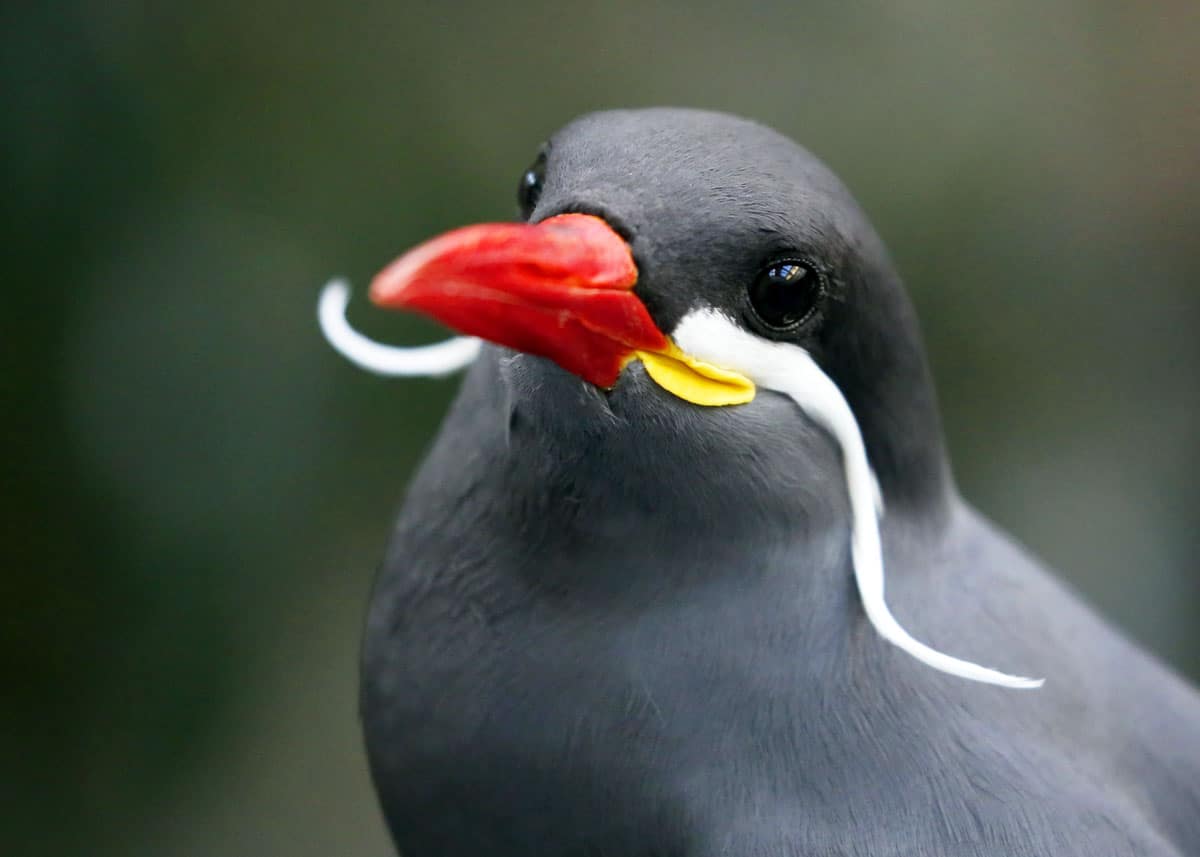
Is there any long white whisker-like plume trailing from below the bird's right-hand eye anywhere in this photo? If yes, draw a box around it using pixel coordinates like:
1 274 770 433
672 308 1045 688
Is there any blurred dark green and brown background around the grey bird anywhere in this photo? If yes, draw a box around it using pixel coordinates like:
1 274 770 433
0 0 1200 857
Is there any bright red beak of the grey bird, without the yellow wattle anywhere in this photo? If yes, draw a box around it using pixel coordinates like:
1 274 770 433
371 214 670 388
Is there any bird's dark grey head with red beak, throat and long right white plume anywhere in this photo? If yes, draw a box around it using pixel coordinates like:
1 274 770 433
323 109 1040 688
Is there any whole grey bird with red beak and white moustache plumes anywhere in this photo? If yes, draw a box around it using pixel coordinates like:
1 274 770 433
319 108 1200 857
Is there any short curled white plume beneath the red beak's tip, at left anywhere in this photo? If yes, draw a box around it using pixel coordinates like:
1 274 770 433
317 280 482 378
